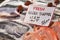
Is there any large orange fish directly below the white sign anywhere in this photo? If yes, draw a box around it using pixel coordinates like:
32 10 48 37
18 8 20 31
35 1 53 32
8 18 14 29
24 27 58 40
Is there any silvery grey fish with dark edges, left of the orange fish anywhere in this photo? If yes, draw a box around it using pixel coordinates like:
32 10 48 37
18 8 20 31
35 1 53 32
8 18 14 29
0 21 32 38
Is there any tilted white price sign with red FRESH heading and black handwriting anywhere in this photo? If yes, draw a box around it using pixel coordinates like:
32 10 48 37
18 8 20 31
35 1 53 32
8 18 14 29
24 5 55 26
